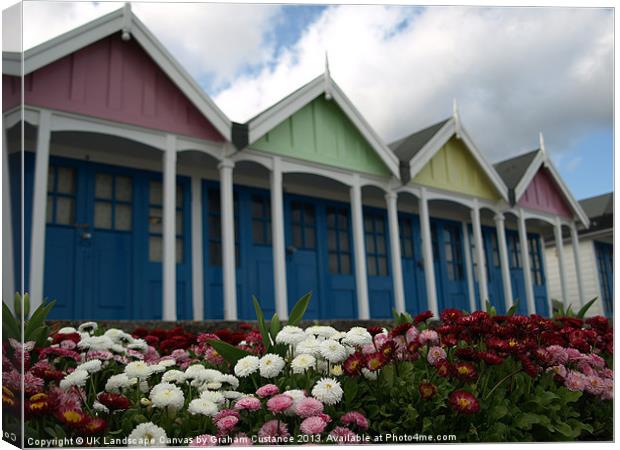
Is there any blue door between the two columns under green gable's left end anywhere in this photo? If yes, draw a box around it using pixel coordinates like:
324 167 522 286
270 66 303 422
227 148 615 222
237 187 275 320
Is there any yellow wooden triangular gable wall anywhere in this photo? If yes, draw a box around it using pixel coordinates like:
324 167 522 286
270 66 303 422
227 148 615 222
411 137 501 200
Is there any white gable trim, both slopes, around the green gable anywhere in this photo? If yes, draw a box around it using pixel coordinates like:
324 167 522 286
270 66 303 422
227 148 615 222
248 75 400 177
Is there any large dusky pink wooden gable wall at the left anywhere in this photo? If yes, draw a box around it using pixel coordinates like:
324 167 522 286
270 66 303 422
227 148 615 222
9 33 224 141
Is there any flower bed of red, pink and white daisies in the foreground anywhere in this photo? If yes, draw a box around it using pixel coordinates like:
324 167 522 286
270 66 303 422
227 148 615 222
2 297 613 446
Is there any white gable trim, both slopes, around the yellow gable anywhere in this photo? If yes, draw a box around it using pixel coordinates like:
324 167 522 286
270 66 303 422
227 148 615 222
409 118 508 201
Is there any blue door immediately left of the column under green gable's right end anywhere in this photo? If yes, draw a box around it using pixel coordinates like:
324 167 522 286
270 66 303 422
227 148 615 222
319 202 358 319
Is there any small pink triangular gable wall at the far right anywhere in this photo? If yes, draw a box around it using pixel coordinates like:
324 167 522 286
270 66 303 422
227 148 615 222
517 167 572 217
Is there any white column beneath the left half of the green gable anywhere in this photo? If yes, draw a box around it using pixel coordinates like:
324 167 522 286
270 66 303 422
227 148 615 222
271 158 288 320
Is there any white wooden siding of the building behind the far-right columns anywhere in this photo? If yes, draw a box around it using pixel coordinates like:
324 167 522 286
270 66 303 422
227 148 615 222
545 240 605 316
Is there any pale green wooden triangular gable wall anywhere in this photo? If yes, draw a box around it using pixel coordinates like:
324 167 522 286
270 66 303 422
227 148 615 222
251 95 391 176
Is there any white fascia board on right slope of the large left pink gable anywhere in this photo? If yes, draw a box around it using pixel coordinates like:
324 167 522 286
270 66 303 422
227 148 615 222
130 13 232 141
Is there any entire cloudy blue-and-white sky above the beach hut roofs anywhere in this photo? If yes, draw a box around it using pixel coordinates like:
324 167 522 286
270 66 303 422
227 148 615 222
3 2 614 198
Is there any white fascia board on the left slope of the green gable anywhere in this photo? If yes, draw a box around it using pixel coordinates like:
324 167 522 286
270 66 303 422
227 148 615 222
248 75 324 145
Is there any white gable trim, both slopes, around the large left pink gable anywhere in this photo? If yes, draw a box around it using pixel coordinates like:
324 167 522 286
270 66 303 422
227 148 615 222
2 7 232 141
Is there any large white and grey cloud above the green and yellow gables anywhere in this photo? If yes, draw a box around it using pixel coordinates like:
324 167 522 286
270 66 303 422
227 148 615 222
215 6 613 160
